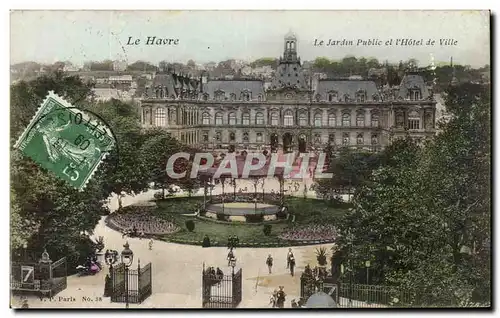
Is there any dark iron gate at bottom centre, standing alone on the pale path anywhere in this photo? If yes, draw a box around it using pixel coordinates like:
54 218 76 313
202 267 242 308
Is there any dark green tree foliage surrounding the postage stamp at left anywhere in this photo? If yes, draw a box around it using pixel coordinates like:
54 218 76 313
10 72 109 268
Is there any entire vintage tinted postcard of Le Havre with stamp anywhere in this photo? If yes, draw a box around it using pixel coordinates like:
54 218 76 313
10 11 492 310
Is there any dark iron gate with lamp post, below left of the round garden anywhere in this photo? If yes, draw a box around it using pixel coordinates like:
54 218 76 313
111 263 152 304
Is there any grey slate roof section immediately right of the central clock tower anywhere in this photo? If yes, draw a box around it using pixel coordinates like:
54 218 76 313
315 79 380 101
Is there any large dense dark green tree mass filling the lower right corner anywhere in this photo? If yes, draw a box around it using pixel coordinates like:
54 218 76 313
338 84 491 306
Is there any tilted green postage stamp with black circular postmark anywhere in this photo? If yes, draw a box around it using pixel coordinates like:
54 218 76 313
14 91 115 190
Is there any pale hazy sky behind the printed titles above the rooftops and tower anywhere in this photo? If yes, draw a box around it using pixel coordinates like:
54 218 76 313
10 11 490 67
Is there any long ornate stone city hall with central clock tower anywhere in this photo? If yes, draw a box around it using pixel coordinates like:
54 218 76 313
140 33 436 152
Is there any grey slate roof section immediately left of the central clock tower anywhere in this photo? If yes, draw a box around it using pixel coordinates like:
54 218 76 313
203 80 264 99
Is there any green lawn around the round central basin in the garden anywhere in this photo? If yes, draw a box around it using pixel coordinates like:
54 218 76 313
150 197 354 245
